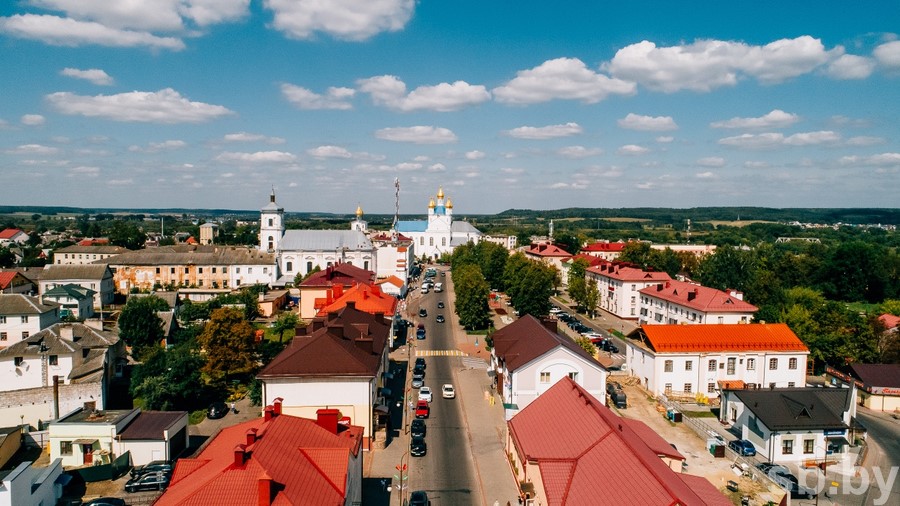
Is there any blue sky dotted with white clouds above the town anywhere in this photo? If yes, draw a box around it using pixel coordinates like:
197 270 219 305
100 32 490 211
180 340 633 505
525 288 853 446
0 0 900 213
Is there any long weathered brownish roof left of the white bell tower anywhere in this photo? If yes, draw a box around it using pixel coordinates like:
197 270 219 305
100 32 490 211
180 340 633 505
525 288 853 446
104 244 275 266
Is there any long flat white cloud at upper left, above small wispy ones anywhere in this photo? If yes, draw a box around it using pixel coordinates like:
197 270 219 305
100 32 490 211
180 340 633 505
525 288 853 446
46 88 234 125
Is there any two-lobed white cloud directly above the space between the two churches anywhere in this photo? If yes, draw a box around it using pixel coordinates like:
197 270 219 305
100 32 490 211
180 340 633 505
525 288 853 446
357 75 491 112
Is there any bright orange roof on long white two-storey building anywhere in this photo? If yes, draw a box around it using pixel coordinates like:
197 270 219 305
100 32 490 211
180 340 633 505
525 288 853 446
641 323 809 353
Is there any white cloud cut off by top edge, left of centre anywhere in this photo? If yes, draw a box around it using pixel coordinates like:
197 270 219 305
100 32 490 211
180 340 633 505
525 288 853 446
263 0 415 40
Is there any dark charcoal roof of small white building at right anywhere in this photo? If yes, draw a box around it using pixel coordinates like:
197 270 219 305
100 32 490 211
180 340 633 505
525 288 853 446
728 387 850 431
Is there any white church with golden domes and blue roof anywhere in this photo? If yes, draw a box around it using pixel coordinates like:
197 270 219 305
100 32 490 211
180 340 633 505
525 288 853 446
397 187 481 259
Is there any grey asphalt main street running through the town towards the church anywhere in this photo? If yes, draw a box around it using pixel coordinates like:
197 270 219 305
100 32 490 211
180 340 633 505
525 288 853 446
409 277 481 505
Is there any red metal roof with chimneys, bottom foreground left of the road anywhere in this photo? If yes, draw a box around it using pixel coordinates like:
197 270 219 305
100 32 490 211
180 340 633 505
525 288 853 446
154 415 363 506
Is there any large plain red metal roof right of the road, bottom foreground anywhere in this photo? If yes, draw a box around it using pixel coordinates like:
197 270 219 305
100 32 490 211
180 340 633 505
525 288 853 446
509 378 728 506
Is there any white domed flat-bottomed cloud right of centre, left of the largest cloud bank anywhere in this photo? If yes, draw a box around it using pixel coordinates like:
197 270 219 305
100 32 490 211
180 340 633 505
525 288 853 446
492 58 636 104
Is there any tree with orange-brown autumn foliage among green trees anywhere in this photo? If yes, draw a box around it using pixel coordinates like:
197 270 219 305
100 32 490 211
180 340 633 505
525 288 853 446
197 308 257 381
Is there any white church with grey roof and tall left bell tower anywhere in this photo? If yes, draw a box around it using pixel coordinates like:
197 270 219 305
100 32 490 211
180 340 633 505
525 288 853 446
259 190 377 285
